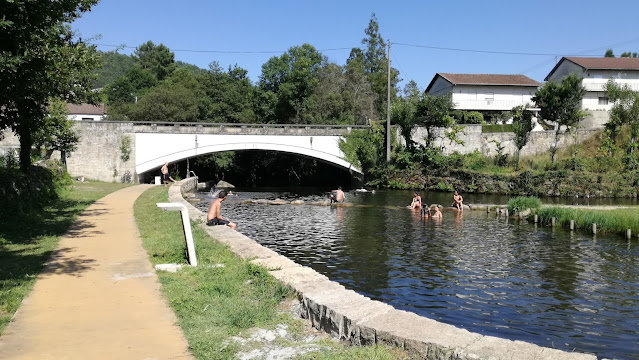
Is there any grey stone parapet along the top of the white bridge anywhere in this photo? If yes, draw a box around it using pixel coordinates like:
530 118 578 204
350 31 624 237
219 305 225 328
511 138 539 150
132 122 369 135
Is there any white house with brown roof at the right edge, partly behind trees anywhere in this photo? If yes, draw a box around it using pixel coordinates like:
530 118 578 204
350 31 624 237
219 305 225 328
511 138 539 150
545 57 639 112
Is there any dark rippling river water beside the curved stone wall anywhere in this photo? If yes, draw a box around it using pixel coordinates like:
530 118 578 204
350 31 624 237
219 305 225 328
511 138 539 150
198 190 639 359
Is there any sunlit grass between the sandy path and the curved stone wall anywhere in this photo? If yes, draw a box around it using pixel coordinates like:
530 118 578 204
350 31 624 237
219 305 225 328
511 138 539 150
135 187 407 360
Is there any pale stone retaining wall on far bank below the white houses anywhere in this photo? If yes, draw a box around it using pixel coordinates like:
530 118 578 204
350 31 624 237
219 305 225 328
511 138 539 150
412 125 600 156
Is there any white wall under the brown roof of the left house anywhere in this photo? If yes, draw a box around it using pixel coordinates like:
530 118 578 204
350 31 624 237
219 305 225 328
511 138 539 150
453 85 537 111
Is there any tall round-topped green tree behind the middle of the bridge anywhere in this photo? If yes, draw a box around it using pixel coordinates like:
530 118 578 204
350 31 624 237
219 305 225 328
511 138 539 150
260 44 326 124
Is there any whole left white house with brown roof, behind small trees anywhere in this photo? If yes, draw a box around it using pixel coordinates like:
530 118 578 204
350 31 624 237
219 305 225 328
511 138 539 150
426 73 541 113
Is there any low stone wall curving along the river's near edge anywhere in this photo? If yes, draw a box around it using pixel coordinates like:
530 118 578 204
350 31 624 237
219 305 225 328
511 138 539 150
169 179 596 360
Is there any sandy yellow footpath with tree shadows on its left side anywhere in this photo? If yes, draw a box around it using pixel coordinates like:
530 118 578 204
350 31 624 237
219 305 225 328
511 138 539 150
0 185 192 360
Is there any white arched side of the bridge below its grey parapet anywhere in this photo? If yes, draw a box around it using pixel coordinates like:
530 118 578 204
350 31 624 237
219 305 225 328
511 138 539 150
135 133 362 176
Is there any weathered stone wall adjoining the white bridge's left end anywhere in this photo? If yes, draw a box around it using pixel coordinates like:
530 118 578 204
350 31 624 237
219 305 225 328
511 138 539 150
67 121 137 182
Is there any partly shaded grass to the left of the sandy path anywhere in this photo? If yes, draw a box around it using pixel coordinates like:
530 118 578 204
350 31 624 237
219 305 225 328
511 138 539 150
0 182 132 334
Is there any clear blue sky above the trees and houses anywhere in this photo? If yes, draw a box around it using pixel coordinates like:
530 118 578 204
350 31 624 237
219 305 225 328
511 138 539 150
72 0 639 89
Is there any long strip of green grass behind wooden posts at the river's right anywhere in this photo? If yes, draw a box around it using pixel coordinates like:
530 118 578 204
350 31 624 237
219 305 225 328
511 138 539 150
537 206 639 236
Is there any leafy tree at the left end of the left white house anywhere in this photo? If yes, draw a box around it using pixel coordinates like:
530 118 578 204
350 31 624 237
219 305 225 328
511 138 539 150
417 94 458 147
